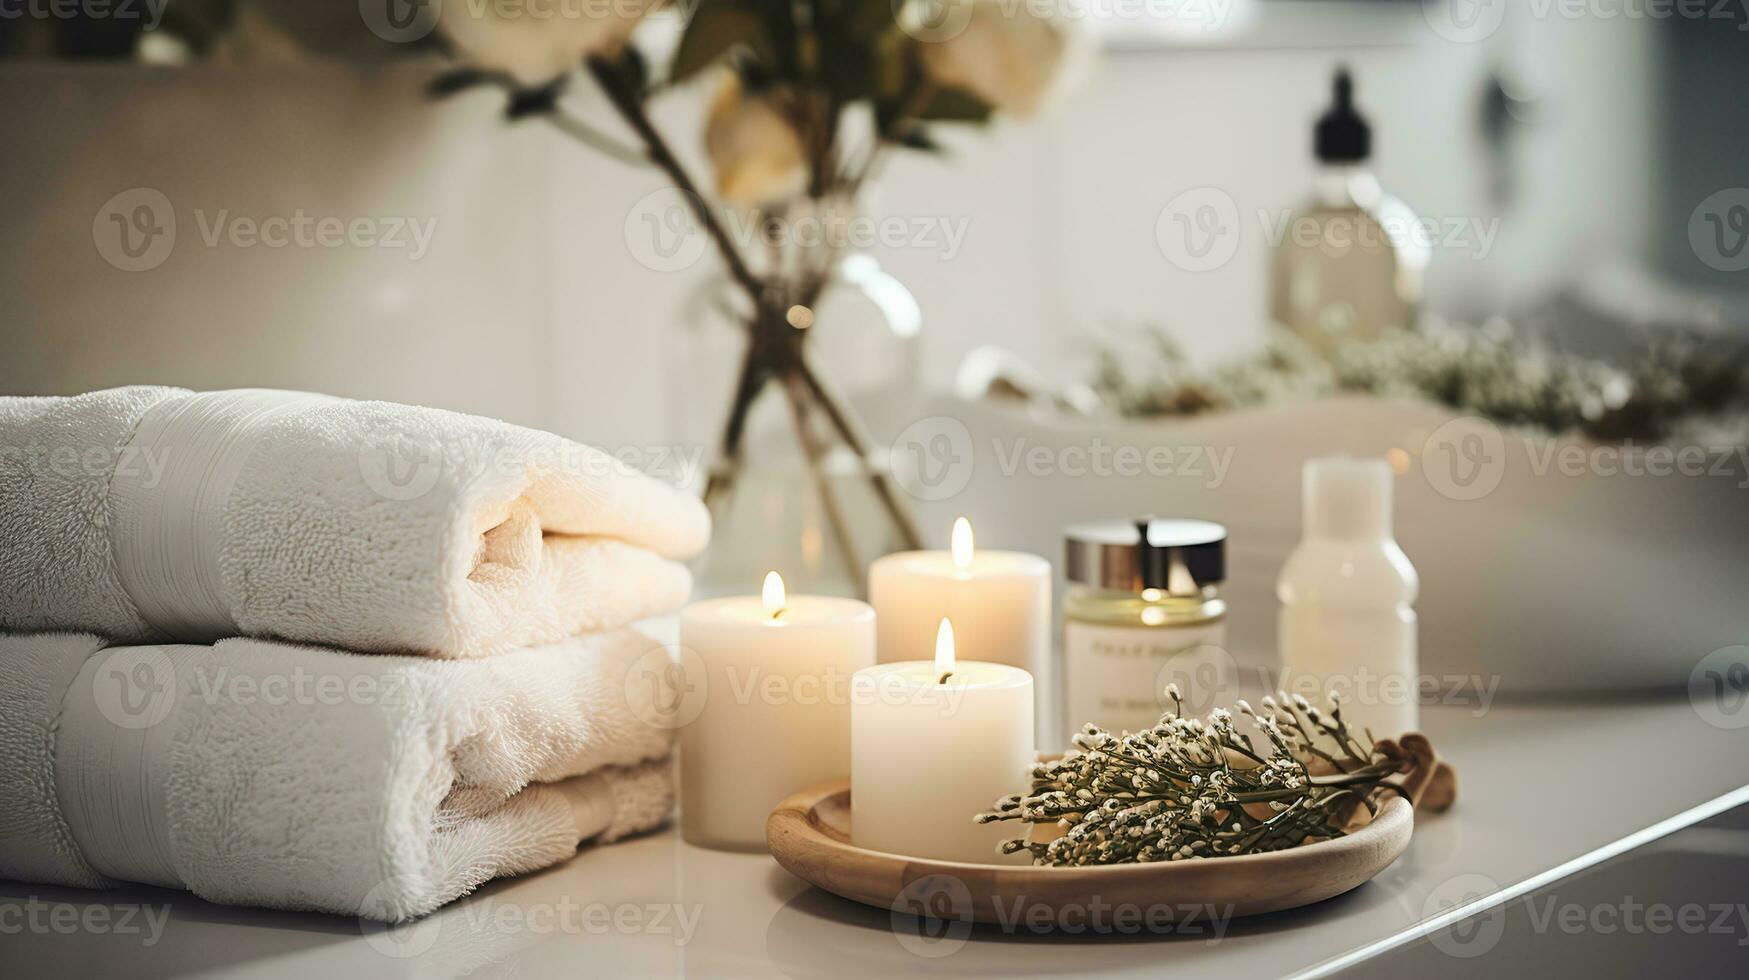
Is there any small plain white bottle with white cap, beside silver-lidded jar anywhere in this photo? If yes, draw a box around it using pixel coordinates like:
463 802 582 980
1275 457 1420 744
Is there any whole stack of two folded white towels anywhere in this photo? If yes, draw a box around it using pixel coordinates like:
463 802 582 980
0 387 710 922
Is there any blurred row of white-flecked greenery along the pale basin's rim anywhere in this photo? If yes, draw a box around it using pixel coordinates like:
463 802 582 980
1091 322 1749 441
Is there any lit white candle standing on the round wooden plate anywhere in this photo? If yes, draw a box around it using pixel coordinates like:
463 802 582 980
850 620 1037 865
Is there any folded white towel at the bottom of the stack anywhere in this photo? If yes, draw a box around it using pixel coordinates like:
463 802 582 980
0 630 673 922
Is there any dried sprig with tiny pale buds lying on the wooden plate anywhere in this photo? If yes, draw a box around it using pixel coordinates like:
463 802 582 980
976 684 1415 866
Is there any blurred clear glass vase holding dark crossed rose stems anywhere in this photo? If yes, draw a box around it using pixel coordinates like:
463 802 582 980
670 254 922 597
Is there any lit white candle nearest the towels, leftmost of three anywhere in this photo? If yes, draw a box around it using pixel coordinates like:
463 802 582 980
680 572 875 851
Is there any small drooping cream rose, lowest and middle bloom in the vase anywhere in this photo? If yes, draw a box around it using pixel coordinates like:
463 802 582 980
705 74 808 207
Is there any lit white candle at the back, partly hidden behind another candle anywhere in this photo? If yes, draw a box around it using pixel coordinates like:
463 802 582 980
869 518 1051 677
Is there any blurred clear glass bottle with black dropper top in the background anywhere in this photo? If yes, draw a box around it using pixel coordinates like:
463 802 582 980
1270 70 1431 355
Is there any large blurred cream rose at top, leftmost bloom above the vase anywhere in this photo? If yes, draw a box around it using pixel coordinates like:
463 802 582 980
437 0 663 86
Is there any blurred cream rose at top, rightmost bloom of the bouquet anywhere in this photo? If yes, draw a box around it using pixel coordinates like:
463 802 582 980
913 0 1072 116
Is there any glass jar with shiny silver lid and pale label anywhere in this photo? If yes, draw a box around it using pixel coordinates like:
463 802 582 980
1058 518 1237 737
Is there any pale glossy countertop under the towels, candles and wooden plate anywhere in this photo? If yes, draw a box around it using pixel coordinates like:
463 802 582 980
0 695 1749 980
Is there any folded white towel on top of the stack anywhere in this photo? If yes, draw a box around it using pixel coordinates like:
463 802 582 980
0 387 710 658
